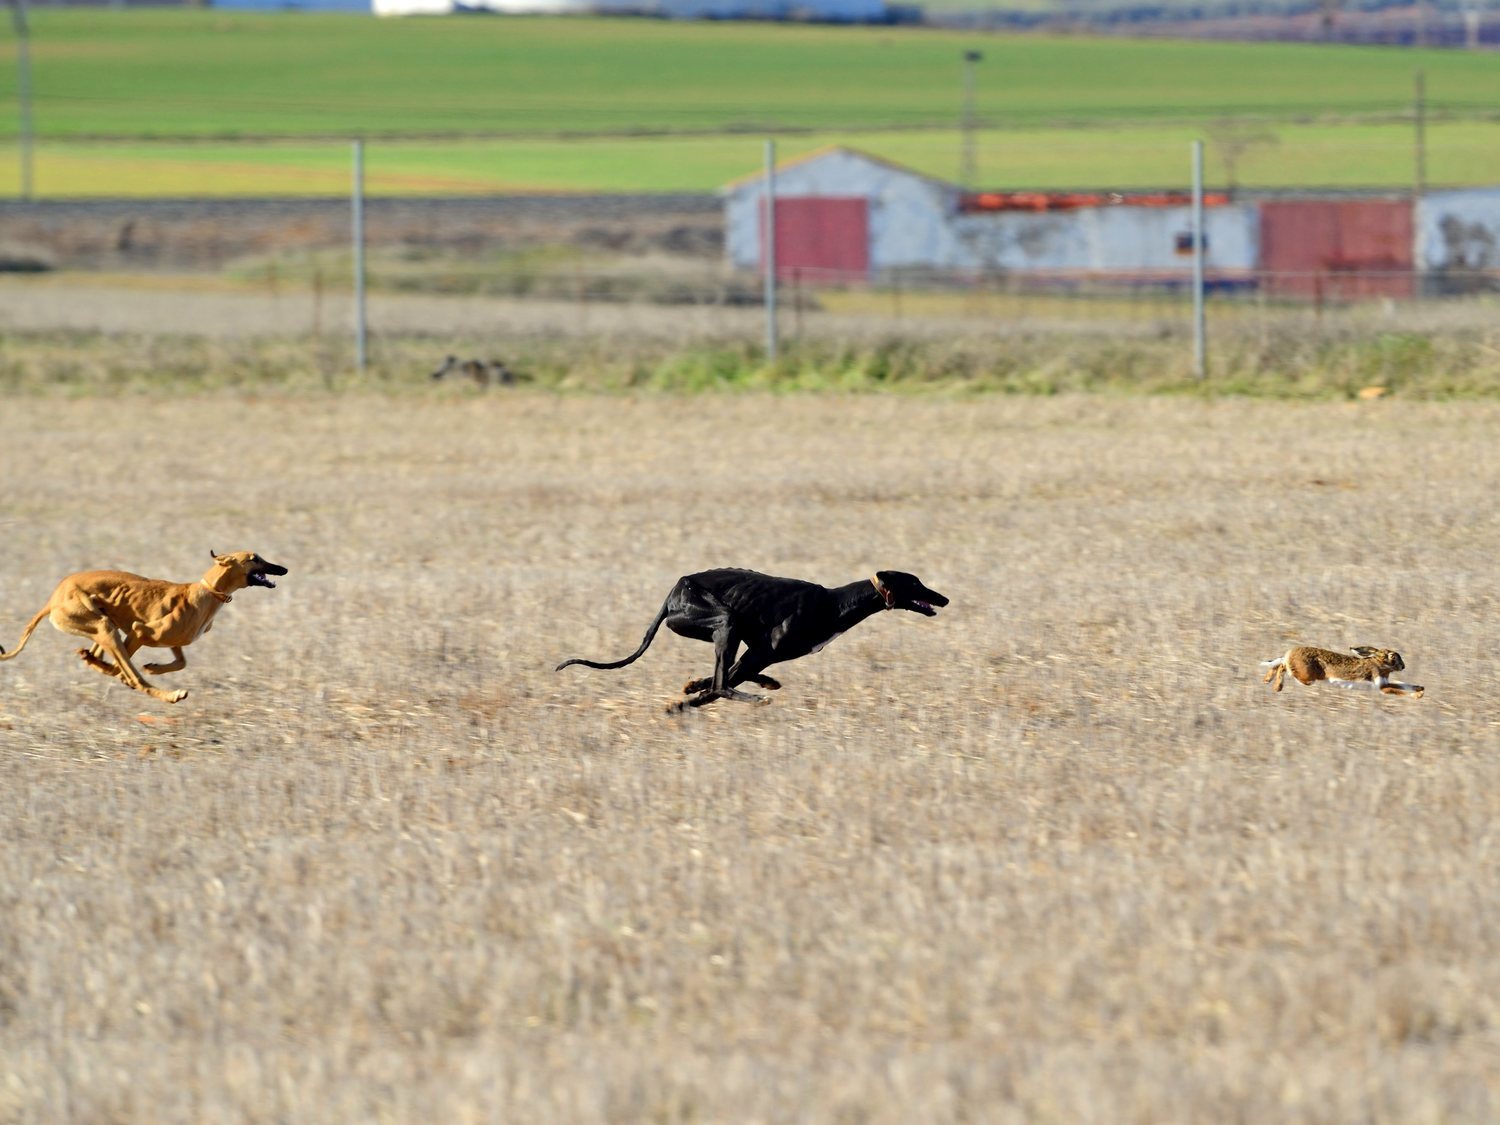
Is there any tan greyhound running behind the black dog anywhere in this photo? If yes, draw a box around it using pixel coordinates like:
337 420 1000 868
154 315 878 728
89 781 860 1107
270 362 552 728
0 551 287 704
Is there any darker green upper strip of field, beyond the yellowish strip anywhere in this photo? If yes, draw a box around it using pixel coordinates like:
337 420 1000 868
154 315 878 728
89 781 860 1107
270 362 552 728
0 12 1500 140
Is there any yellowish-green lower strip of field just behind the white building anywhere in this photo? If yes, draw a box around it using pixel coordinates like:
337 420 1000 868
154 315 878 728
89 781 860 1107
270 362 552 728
0 122 1500 198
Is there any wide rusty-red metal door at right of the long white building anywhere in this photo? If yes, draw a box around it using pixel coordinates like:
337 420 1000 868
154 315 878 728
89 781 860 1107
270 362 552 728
1260 200 1415 300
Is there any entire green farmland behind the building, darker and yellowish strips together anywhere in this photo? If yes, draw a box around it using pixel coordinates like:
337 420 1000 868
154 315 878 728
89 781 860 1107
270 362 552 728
0 11 1500 197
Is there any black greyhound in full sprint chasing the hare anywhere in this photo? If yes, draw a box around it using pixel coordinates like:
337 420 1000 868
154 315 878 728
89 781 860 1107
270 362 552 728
558 567 948 711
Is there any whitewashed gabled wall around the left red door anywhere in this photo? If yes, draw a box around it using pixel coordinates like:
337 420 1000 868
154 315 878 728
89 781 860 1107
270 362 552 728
725 149 960 270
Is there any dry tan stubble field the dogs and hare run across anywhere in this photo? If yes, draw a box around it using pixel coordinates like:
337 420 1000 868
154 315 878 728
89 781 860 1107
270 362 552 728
0 393 1500 1122
